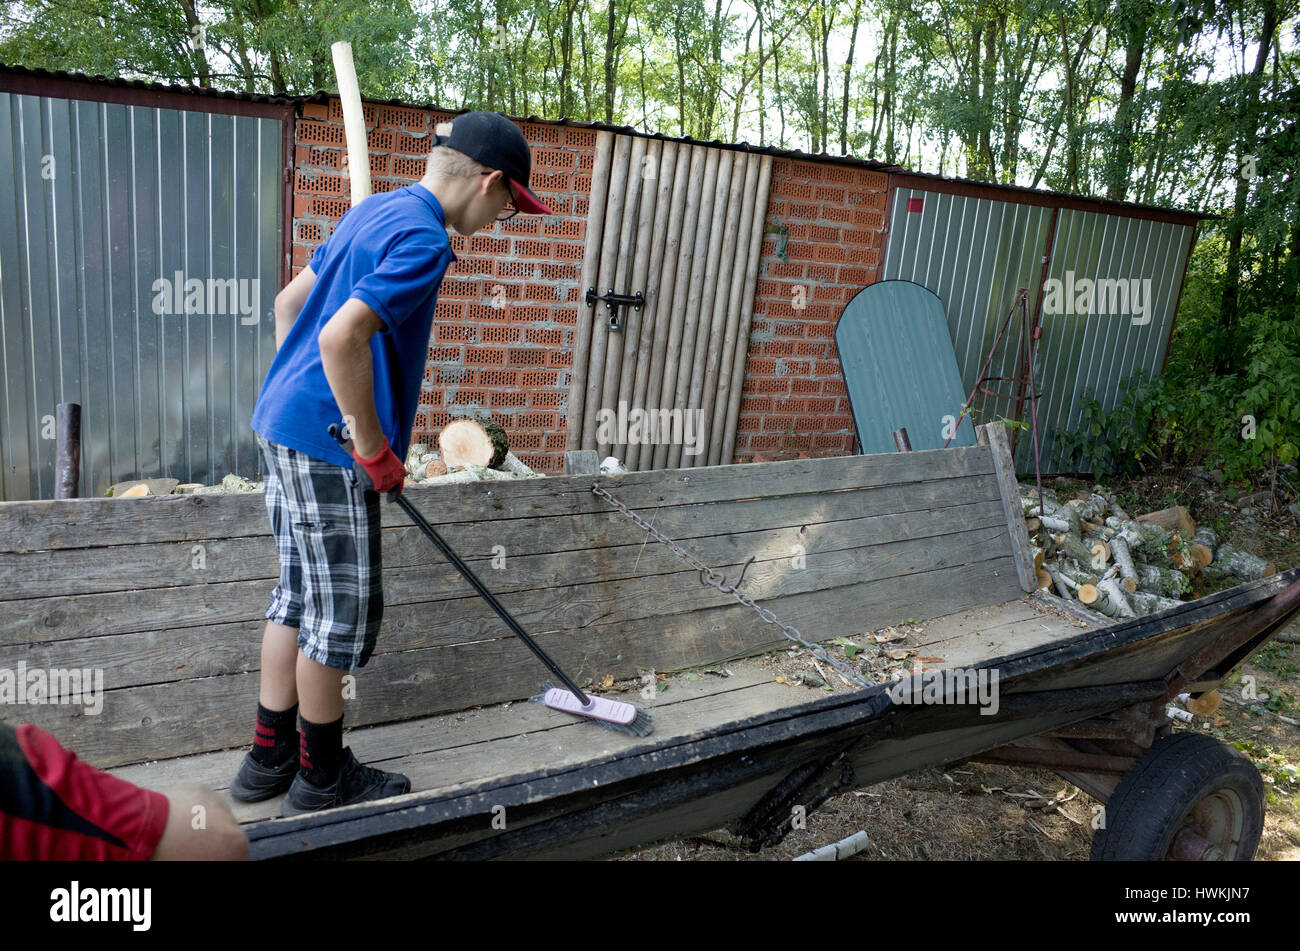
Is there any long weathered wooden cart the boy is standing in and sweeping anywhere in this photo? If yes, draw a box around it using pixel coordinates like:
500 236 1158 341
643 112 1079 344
0 427 1300 859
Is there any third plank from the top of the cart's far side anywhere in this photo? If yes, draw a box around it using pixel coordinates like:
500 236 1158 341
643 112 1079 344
0 503 1005 650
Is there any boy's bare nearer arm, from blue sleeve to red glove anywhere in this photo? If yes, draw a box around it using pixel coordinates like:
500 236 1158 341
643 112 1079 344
317 298 387 459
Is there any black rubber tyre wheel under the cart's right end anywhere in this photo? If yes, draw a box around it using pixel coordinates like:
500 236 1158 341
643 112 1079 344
1091 733 1264 861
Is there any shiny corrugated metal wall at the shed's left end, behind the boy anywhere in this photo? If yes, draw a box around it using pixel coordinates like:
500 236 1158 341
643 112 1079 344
0 94 282 500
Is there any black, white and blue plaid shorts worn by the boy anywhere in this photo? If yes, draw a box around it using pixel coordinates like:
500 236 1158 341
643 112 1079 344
255 433 384 670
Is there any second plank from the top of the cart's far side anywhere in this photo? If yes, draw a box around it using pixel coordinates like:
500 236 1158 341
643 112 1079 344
0 474 1001 597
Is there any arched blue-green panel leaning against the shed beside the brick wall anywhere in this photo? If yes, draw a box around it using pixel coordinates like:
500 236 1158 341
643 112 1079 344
835 281 975 453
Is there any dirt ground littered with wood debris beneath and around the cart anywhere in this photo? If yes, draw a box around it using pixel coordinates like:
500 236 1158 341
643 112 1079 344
608 459 1300 861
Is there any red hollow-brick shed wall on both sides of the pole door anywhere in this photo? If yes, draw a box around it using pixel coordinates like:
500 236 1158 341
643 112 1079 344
291 99 887 473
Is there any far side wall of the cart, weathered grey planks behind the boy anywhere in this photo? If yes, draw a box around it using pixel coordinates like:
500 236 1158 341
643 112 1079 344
0 446 1021 767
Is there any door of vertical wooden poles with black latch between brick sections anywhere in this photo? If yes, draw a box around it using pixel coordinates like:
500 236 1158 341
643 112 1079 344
567 131 772 472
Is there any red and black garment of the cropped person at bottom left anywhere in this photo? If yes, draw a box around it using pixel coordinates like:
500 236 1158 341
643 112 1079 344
0 724 168 860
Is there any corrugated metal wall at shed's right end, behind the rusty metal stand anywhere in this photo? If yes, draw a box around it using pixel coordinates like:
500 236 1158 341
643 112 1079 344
880 186 1192 473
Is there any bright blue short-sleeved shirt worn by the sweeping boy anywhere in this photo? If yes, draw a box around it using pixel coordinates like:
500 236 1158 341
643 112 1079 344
252 182 456 468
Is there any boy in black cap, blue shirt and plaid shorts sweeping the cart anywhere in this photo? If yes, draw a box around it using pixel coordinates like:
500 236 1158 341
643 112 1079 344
230 112 550 816
